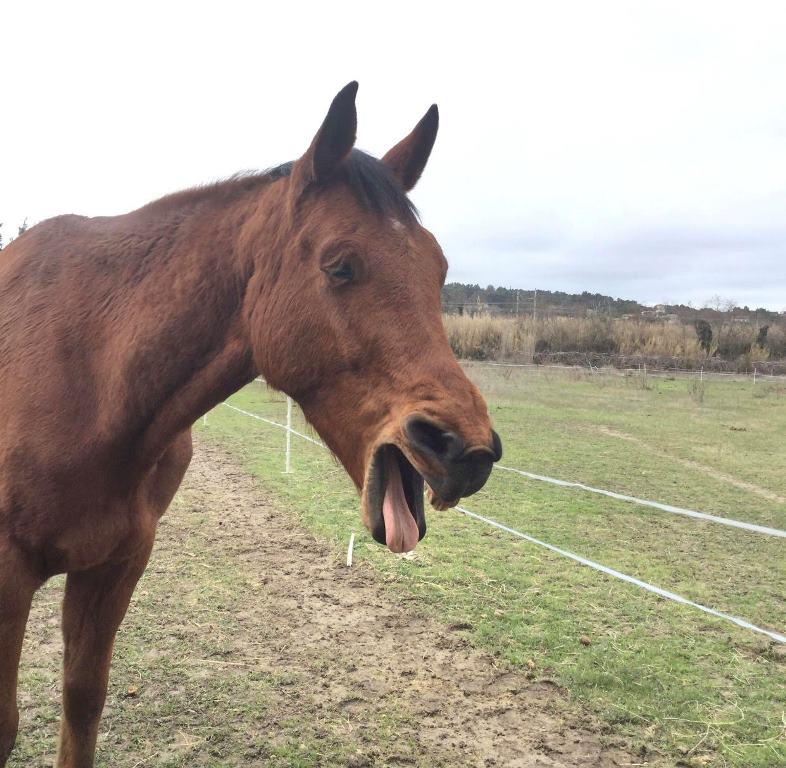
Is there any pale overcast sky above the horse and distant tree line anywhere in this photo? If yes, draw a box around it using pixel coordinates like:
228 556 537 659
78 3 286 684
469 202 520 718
0 0 786 310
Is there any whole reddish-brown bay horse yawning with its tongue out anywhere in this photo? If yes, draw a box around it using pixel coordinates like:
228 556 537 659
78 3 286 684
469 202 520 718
0 83 501 768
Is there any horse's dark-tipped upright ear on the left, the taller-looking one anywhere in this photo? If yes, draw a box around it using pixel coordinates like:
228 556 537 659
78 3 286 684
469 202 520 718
292 80 358 192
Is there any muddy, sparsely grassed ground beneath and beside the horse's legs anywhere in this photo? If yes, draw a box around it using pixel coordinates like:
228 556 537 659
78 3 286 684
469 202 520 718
11 441 646 768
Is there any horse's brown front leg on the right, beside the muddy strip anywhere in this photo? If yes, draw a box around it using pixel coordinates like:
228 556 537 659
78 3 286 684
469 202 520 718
57 532 153 768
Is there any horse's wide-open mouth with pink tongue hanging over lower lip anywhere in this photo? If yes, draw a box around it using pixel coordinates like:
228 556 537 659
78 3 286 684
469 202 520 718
364 444 426 552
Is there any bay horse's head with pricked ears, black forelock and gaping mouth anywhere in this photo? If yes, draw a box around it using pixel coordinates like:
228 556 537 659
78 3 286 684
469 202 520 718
247 82 501 552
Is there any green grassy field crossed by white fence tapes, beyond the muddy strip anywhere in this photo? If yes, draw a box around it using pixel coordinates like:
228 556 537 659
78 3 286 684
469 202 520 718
198 365 786 768
